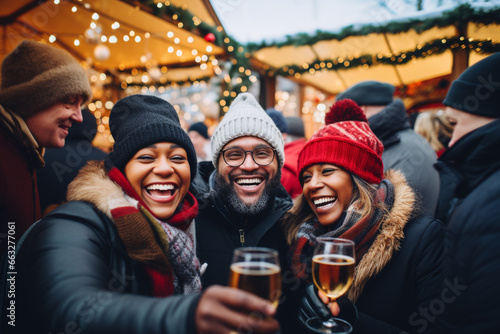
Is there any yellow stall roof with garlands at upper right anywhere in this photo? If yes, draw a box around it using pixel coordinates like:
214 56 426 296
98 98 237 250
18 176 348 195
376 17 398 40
246 3 500 94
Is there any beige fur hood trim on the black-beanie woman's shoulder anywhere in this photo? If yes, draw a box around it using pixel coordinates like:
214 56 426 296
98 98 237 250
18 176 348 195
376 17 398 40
66 161 130 219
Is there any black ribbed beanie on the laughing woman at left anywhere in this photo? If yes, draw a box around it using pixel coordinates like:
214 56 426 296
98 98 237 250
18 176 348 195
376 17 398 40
109 94 197 180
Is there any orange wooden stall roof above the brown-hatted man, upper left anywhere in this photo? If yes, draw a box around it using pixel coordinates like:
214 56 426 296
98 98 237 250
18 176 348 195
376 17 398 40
0 0 225 81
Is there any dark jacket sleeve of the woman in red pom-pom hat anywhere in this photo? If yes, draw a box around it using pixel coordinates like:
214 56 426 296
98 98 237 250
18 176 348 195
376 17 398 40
354 216 444 334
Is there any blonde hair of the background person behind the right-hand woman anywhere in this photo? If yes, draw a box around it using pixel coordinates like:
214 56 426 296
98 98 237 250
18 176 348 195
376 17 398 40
414 111 453 152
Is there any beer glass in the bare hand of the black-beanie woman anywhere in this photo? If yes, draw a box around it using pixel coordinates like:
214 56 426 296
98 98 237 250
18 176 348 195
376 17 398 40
228 247 281 307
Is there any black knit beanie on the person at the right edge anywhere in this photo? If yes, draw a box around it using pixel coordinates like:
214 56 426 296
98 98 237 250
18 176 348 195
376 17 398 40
443 52 500 118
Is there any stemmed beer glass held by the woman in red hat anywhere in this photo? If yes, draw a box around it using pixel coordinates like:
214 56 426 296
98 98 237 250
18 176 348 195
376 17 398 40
306 237 355 333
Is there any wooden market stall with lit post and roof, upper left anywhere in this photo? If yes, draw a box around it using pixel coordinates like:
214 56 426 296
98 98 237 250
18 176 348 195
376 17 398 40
0 0 232 144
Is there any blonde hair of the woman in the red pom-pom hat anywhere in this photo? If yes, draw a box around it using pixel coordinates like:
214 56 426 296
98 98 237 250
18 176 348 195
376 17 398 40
283 173 388 245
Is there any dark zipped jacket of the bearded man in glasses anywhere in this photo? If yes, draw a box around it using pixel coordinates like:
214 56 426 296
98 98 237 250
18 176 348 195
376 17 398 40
191 162 304 334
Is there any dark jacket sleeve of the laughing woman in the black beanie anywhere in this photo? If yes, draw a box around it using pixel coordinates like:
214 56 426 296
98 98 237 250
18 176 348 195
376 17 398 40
7 201 199 334
